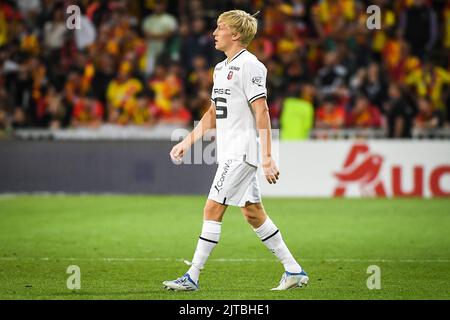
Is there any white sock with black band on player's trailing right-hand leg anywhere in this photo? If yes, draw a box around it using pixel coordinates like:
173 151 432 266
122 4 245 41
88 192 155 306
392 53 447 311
253 217 302 273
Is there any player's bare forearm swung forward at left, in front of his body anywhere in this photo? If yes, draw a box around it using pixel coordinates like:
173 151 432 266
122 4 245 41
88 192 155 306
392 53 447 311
170 102 216 161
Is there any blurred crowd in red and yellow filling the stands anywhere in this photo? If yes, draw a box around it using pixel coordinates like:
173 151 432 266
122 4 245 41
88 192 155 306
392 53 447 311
0 0 450 139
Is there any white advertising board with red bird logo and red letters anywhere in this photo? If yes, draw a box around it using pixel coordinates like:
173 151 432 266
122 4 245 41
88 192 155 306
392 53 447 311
262 140 450 198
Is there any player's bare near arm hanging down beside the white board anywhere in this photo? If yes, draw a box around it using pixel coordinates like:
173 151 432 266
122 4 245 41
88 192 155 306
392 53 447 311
251 98 280 184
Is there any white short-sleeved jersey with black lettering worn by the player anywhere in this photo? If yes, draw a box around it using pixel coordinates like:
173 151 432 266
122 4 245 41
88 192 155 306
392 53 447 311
211 49 267 166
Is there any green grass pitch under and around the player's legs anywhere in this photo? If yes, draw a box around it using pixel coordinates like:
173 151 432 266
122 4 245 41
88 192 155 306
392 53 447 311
0 195 450 300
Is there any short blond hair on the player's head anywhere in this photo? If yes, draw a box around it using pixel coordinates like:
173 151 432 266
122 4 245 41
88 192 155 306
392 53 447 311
217 10 258 47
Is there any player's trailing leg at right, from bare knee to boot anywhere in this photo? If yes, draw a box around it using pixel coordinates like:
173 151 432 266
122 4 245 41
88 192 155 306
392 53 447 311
241 202 308 290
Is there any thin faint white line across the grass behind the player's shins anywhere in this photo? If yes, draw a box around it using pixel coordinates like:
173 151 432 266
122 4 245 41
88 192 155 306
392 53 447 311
0 257 450 263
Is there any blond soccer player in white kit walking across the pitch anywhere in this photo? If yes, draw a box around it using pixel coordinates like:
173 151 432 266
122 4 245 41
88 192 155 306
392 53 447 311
163 10 309 291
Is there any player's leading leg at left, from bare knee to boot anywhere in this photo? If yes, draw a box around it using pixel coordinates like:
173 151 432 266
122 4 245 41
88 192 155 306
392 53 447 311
163 199 227 291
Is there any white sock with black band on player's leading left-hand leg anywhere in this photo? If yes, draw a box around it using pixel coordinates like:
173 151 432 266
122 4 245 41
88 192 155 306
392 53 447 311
187 220 222 283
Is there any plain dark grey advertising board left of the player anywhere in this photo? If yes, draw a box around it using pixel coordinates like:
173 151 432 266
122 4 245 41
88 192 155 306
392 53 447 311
0 140 215 194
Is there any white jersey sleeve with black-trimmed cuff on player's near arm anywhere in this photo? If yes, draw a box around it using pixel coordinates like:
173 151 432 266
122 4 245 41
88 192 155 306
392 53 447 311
242 61 267 103
